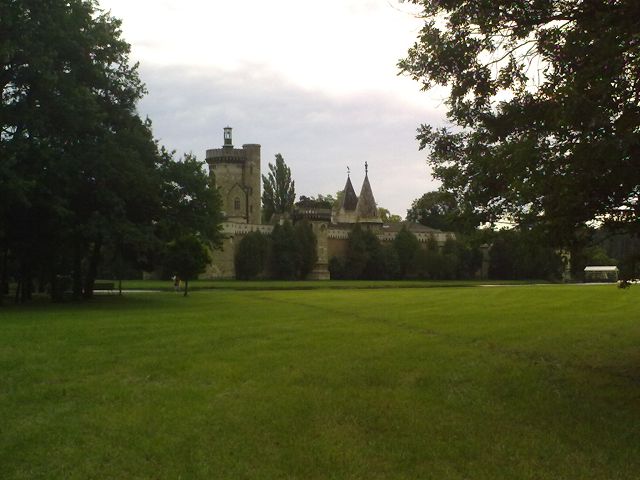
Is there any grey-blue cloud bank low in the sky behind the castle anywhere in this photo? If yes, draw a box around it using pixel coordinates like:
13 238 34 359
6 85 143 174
139 64 444 215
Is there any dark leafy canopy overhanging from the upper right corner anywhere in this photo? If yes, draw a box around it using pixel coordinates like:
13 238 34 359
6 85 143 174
399 0 640 243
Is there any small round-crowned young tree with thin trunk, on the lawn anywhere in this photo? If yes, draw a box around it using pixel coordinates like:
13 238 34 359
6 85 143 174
164 235 211 297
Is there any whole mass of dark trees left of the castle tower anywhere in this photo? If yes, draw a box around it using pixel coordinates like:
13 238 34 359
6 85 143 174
0 0 221 302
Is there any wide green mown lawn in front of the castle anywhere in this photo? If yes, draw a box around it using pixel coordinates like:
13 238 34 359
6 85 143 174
0 285 640 480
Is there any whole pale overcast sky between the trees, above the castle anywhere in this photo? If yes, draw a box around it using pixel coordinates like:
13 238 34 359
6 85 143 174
101 0 445 216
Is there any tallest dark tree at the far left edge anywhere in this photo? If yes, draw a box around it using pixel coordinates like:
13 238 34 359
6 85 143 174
0 0 144 299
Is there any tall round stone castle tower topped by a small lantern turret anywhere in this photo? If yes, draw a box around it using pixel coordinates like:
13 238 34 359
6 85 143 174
206 127 262 224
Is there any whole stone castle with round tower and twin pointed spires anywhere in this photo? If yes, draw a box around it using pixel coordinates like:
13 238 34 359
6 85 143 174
201 127 454 280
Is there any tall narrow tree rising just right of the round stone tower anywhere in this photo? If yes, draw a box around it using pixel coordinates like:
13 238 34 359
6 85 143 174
262 153 296 222
